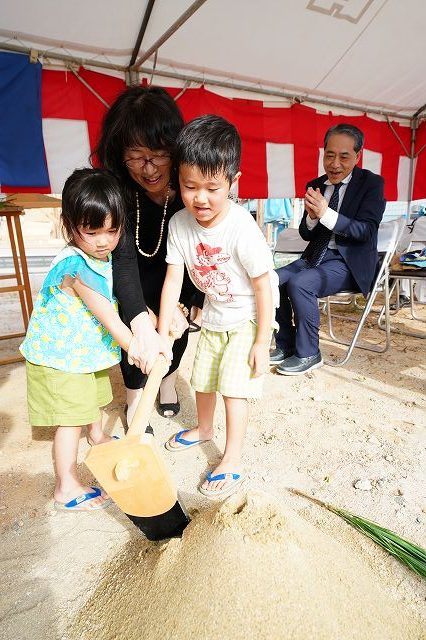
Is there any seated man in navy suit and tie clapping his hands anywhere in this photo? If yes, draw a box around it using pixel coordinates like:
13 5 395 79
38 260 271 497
270 124 385 376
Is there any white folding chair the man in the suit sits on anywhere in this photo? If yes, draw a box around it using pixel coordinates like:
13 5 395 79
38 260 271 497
325 218 405 367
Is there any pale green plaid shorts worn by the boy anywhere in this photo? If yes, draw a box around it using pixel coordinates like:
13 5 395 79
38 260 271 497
191 320 264 398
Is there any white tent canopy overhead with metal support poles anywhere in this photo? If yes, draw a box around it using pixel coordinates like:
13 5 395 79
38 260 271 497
0 0 426 119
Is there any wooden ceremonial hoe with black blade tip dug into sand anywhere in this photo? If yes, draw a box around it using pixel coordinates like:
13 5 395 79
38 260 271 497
85 322 189 540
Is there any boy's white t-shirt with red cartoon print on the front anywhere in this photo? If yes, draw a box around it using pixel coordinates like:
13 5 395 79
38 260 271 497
166 201 279 331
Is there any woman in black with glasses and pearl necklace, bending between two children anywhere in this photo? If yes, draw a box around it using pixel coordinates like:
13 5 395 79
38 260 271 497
96 87 195 423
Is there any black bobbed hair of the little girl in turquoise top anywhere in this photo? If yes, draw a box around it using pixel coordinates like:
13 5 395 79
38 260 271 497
61 169 125 242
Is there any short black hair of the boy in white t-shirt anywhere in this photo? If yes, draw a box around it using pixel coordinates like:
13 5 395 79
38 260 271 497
175 115 241 184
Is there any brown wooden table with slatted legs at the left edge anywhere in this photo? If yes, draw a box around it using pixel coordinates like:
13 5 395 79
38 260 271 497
0 193 61 365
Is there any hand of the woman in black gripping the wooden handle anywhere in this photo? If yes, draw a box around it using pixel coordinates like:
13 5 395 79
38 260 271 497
127 311 172 373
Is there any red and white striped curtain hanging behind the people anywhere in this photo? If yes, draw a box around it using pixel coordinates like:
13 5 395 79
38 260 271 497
3 69 426 200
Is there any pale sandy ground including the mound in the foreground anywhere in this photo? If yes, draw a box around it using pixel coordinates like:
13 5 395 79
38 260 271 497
0 288 426 640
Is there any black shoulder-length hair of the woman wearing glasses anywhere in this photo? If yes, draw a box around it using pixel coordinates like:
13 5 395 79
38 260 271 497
94 86 184 196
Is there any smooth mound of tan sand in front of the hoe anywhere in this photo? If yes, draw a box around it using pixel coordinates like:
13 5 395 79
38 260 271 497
67 492 424 640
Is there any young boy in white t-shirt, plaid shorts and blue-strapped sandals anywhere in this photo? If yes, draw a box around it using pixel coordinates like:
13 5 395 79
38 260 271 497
158 115 278 498
